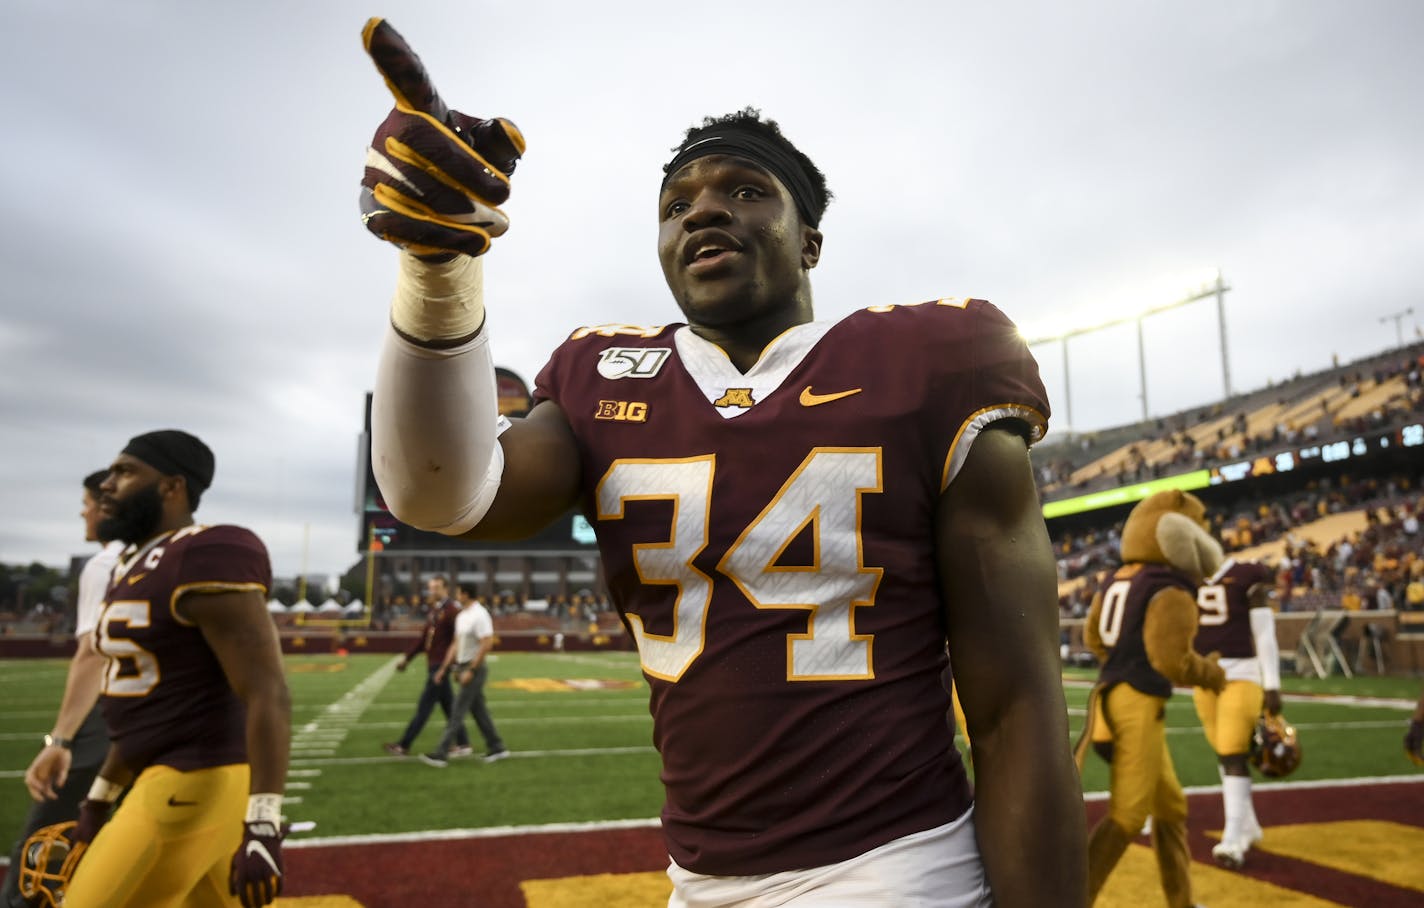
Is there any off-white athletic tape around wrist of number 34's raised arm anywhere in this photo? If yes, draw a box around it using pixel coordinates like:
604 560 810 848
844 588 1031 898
390 252 484 340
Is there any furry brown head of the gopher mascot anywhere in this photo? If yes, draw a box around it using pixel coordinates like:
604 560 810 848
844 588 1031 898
1122 488 1223 582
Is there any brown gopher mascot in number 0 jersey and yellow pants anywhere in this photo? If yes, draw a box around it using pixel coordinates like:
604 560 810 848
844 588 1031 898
1075 490 1226 908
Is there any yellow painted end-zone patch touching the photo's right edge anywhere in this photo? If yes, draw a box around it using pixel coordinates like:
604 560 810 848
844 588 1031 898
1256 820 1424 892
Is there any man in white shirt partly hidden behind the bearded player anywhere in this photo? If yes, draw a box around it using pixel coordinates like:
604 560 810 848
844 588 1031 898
0 470 124 908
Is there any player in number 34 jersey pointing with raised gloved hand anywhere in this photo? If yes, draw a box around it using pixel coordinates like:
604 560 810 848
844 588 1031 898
353 20 1087 908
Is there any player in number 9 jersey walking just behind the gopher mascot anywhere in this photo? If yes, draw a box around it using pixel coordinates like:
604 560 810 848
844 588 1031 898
1192 558 1280 868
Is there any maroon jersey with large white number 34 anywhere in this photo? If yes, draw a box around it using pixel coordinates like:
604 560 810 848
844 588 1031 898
535 300 1048 875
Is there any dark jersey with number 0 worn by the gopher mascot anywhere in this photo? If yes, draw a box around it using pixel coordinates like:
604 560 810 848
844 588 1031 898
1098 564 1196 697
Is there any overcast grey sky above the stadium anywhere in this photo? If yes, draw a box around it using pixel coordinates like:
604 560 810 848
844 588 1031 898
0 0 1424 575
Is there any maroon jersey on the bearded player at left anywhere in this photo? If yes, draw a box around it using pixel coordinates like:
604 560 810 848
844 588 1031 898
97 525 272 773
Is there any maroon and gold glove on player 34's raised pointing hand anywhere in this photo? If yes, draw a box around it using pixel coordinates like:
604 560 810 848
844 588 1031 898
360 19 524 256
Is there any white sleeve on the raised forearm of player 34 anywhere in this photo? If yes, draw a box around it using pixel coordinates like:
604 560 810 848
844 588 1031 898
370 327 508 537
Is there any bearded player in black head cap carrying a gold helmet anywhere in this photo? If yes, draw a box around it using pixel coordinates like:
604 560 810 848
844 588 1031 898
64 430 290 908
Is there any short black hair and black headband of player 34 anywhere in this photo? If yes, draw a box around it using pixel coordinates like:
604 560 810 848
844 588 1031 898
662 107 834 226
